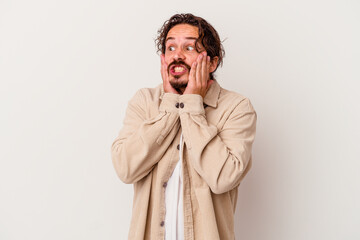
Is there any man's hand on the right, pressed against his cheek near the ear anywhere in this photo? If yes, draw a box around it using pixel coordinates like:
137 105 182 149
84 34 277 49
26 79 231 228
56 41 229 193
184 51 214 98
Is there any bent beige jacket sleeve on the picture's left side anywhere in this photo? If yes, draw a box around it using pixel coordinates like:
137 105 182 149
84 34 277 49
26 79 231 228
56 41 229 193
111 90 180 183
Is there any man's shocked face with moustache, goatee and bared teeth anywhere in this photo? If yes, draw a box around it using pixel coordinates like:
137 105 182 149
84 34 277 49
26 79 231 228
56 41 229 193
165 24 205 89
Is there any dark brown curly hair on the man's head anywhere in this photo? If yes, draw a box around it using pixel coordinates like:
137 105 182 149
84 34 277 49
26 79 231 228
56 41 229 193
155 13 225 79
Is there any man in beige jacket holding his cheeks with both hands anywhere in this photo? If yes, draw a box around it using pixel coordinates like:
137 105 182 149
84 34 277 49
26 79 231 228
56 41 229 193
111 14 256 240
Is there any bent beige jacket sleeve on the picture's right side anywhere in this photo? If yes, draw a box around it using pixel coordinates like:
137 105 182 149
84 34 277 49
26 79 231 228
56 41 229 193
179 94 257 194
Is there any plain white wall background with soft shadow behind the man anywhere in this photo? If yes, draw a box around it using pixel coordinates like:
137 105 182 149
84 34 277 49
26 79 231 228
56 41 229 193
0 0 360 240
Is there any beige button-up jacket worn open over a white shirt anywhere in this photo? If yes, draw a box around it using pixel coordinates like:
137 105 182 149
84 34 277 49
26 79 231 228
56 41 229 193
111 81 256 240
